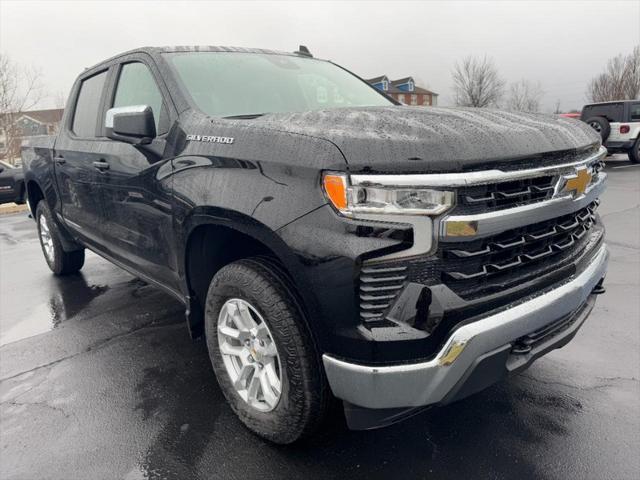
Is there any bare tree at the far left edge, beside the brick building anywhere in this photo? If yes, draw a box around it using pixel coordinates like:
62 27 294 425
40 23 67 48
0 53 44 160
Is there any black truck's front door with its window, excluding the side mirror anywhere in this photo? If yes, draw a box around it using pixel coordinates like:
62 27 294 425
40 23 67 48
93 55 177 290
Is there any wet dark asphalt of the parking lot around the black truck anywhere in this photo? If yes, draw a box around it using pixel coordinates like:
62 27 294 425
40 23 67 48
0 156 640 480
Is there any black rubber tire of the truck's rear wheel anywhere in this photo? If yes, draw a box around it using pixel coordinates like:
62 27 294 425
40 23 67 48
36 200 84 275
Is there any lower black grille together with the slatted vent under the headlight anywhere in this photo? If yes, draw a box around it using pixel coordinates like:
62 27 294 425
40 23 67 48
359 200 603 324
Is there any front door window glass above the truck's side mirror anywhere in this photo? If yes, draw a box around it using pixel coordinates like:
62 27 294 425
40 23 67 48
113 62 168 134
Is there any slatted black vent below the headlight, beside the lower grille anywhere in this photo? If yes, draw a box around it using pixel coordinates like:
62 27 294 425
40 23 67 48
360 265 407 322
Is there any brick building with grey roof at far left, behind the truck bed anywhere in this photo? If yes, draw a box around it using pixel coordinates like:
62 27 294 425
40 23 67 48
0 108 64 164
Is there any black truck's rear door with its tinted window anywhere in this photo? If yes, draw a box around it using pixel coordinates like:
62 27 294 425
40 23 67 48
54 69 109 250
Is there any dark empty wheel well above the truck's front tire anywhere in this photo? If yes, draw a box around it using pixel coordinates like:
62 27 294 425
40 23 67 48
185 225 277 337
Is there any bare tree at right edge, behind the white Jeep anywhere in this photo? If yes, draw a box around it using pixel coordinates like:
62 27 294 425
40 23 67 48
587 45 640 102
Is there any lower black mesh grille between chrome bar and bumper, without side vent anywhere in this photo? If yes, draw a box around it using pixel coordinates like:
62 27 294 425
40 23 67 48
439 200 599 298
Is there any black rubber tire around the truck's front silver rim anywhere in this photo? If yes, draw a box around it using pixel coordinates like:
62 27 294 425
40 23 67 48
205 257 331 444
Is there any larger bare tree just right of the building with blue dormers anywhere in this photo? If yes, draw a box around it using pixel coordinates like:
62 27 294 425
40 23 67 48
452 56 504 107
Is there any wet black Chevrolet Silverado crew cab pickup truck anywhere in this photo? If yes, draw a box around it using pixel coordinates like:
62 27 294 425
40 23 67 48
22 47 608 443
